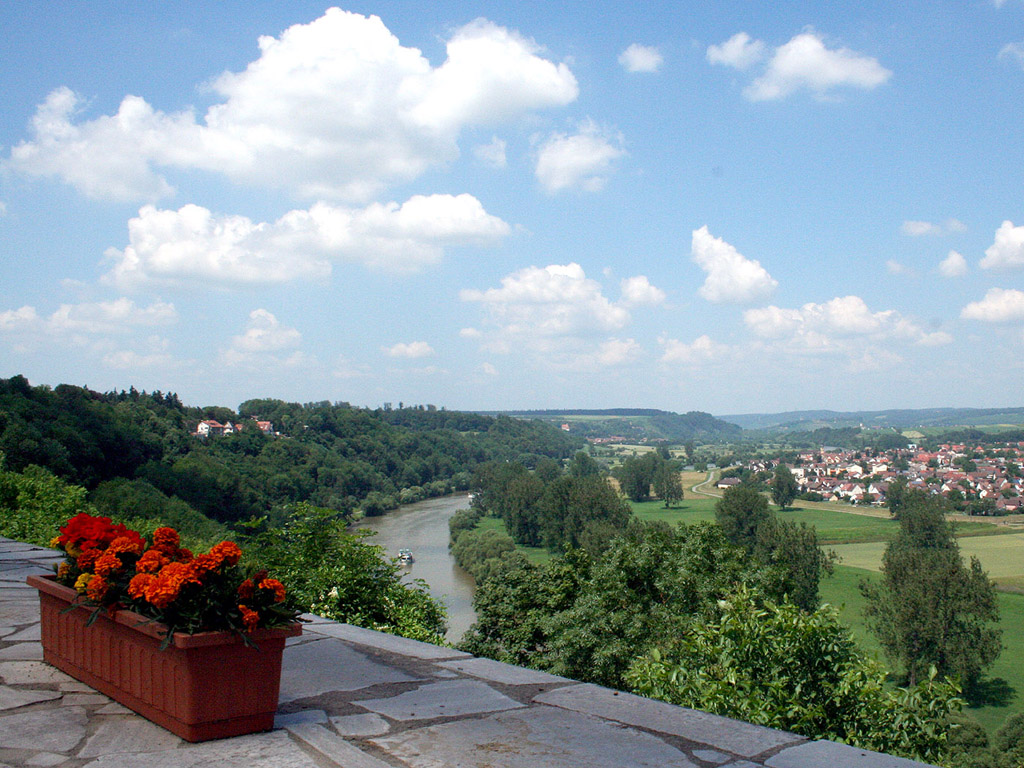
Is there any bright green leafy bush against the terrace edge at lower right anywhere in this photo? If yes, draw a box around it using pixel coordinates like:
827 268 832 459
626 587 963 760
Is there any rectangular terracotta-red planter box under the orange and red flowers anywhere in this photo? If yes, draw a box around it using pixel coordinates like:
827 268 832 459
28 577 302 741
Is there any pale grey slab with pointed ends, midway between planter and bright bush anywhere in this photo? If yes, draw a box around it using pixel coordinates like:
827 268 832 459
352 680 525 721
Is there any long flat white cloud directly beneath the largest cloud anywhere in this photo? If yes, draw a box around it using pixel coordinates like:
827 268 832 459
104 194 509 289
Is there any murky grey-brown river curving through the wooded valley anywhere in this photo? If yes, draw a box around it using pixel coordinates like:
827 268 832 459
353 494 476 642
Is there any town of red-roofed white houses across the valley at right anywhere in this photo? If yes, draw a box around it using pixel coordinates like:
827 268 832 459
737 442 1024 515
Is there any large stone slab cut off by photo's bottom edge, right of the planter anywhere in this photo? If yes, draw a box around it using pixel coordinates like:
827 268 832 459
373 707 697 768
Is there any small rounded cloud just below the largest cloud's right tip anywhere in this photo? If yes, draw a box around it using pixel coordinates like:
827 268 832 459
535 120 626 193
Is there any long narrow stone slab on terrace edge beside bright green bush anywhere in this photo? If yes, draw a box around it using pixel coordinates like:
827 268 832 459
534 684 805 758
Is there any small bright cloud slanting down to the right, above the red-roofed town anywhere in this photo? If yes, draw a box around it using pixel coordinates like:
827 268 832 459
691 226 778 304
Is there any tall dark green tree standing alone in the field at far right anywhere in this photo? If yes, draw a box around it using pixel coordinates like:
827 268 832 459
860 494 1001 689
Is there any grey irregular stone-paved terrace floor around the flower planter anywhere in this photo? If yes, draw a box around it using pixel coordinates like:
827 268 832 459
0 538 937 768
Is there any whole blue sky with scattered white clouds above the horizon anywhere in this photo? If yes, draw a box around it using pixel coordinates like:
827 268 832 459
0 0 1024 414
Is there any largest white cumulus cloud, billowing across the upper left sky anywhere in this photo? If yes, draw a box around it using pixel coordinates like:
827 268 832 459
8 8 579 202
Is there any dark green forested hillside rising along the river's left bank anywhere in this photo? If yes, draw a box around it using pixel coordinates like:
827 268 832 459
0 376 583 522
